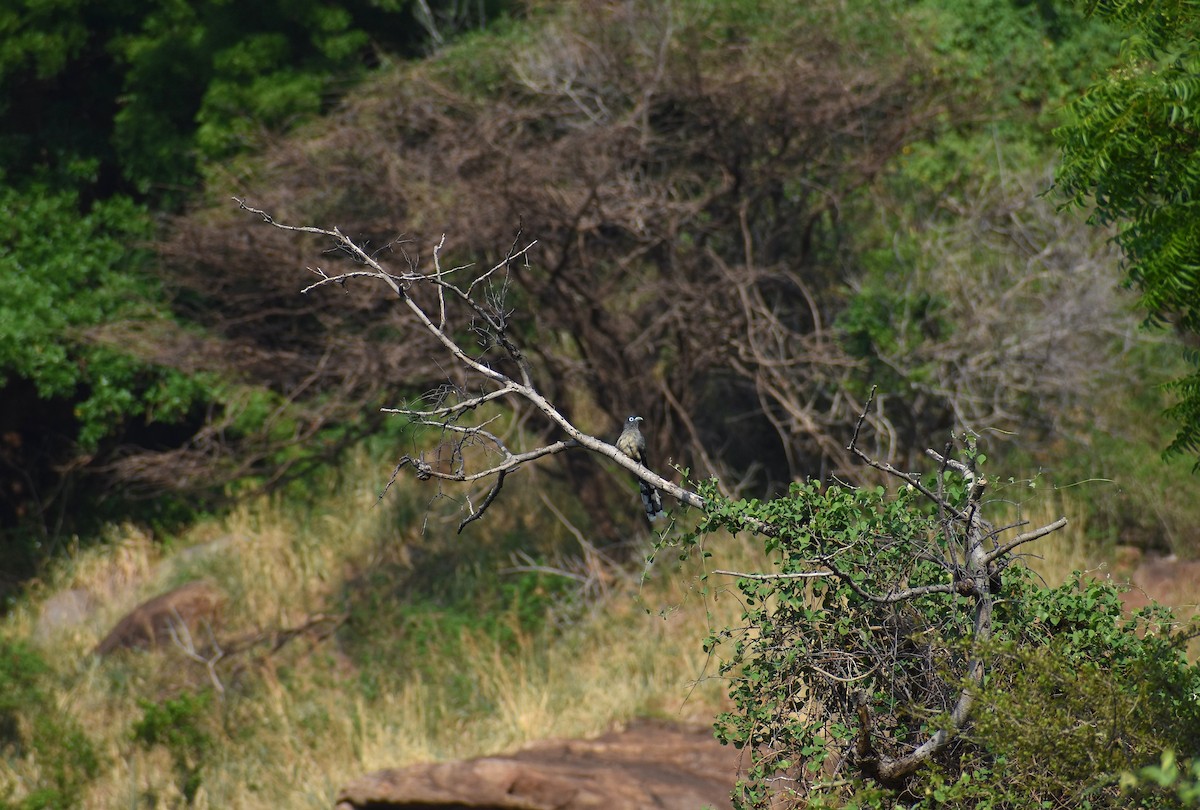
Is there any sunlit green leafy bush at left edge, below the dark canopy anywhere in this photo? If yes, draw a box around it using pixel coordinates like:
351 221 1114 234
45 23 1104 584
0 186 203 452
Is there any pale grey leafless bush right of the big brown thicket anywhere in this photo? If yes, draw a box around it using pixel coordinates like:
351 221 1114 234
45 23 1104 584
852 170 1132 452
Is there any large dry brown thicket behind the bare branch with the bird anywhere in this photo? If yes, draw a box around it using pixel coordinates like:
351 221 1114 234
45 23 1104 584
152 4 940 506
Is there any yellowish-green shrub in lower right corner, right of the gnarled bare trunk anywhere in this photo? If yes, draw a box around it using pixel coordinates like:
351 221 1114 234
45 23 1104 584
965 580 1200 808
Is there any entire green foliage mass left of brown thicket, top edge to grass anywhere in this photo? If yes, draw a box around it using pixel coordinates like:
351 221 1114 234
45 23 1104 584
0 0 506 583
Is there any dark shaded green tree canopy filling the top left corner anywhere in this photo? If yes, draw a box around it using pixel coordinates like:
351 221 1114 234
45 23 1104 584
0 0 504 197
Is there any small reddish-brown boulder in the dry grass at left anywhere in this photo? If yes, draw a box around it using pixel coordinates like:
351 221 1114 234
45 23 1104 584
95 580 221 655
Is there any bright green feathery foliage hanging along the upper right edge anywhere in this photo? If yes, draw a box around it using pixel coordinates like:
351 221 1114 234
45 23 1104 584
1057 0 1200 469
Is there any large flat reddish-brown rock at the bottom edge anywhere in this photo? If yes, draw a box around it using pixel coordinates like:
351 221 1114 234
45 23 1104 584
337 721 738 810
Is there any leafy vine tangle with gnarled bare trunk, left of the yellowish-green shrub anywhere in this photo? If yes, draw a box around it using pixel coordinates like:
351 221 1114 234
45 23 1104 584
697 391 1067 806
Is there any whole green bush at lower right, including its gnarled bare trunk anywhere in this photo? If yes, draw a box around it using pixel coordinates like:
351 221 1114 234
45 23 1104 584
689 444 1200 809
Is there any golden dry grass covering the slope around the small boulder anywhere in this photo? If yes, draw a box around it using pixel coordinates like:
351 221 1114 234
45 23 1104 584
0 458 754 809
